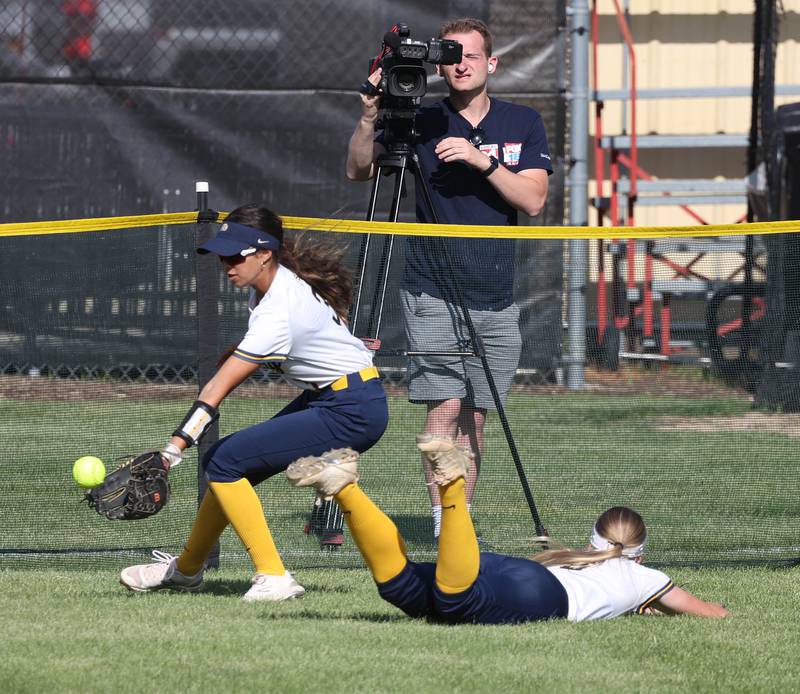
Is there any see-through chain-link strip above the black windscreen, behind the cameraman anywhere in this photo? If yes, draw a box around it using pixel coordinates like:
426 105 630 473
0 0 563 93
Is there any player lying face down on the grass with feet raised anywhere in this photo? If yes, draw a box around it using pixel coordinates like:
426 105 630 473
286 434 727 624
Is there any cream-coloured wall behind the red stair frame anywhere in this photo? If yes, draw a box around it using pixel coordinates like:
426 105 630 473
590 0 800 225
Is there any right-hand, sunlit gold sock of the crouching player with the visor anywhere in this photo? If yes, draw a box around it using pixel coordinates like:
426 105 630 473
208 479 286 576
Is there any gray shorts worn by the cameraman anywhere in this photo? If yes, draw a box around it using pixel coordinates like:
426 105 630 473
401 290 522 410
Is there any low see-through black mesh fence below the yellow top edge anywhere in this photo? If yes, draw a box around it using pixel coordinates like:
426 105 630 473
0 218 800 566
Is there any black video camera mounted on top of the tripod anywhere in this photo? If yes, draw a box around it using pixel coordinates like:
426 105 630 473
360 22 463 145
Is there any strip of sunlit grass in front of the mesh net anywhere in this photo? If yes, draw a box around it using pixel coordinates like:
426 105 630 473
0 568 800 692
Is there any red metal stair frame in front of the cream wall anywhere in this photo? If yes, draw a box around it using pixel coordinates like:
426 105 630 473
587 0 764 380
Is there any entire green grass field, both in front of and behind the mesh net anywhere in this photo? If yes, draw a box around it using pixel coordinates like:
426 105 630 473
0 382 800 692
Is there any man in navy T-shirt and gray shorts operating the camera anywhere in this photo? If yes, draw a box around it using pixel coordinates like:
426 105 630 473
347 18 552 537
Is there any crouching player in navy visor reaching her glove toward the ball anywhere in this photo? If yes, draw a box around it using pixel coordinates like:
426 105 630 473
120 206 388 601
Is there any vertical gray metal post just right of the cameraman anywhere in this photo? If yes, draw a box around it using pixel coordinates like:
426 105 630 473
565 0 589 390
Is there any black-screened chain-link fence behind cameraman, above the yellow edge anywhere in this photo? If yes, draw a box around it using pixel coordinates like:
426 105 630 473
0 0 565 224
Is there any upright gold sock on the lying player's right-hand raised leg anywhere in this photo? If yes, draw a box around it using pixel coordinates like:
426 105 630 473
436 479 481 593
